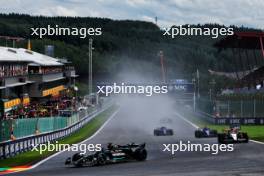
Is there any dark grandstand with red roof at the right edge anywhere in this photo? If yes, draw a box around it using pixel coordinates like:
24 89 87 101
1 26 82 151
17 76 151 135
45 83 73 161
214 32 264 93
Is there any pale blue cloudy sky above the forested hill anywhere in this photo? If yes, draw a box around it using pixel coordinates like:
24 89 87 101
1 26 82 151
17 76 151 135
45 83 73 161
0 0 264 29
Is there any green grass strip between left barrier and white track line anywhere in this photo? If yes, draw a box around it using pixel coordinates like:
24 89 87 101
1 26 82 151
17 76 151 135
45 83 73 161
0 106 117 168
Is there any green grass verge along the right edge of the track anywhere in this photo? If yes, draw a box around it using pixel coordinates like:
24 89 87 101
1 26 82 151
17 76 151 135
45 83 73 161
180 108 264 142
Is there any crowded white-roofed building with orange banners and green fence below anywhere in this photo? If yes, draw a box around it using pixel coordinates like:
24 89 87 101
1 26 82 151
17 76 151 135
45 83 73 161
0 47 78 141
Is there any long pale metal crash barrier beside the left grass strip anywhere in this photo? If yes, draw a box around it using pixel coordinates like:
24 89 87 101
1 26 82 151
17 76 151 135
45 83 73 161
0 103 112 159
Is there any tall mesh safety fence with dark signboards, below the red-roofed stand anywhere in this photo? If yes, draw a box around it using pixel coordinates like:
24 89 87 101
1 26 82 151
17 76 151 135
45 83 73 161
196 98 264 125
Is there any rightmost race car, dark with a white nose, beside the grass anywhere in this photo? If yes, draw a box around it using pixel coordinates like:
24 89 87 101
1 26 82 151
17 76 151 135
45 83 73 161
218 125 249 144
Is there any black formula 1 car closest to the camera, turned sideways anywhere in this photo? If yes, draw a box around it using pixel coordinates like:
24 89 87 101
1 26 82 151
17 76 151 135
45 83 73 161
65 143 147 167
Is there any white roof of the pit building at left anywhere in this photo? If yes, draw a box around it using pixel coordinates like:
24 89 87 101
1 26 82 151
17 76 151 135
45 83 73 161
0 47 63 66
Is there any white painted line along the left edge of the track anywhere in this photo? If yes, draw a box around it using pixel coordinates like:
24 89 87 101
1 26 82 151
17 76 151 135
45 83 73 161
3 108 120 175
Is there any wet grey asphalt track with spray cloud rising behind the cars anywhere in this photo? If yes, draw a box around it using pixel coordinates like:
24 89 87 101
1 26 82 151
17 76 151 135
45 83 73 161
12 98 264 176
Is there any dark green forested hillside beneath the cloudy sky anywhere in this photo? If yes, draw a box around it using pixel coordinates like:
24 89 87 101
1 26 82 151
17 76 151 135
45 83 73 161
0 14 260 91
